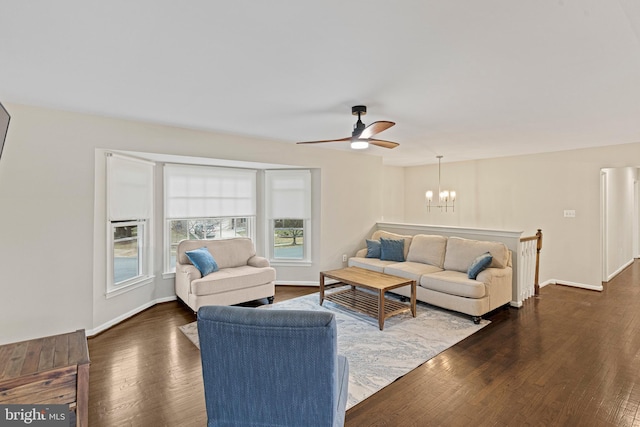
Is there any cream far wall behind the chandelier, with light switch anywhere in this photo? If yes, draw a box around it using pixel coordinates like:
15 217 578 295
405 143 640 289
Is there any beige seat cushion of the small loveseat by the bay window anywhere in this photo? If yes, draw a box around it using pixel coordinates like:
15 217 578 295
191 265 276 295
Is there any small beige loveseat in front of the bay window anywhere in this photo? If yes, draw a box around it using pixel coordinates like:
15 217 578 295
175 238 276 312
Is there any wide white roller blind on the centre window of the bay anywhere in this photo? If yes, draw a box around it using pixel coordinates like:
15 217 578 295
164 165 256 219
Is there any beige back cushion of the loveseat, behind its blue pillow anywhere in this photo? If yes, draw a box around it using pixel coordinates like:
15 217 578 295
178 237 256 268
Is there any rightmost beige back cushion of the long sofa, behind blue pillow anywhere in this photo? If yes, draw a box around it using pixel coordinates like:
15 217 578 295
444 237 509 273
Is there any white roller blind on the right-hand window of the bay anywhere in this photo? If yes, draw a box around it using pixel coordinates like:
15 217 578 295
265 169 311 219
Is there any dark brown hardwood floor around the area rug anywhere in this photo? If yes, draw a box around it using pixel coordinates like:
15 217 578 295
89 261 640 427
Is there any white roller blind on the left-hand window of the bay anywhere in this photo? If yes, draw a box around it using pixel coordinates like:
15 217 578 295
107 153 154 221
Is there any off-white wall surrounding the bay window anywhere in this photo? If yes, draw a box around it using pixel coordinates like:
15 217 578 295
0 104 383 343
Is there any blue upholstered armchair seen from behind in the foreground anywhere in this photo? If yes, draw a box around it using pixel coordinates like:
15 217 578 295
198 306 349 427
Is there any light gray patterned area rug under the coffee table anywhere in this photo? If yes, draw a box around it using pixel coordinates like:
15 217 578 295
180 288 490 409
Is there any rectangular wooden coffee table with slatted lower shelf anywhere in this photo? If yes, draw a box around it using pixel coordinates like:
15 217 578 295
320 267 416 330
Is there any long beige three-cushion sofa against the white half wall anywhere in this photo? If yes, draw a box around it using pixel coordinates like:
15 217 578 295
349 230 513 323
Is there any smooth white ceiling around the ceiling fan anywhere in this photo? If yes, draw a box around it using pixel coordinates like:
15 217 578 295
0 0 640 165
